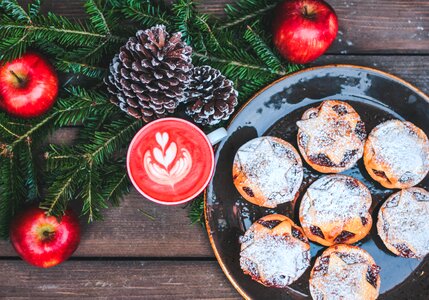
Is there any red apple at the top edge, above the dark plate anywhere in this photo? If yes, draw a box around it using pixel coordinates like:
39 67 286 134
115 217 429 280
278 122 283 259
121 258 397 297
273 0 338 64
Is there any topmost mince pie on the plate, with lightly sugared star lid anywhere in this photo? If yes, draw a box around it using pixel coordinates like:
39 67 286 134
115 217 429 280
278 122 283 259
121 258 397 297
296 100 366 173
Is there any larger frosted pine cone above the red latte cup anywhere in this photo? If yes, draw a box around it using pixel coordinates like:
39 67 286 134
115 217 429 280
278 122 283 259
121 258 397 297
105 25 193 122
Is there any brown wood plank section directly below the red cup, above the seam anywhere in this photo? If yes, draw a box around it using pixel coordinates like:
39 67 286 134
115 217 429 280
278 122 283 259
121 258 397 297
0 190 213 257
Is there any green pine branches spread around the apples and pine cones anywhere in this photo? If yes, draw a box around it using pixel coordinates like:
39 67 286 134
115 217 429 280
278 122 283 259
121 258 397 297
0 0 302 232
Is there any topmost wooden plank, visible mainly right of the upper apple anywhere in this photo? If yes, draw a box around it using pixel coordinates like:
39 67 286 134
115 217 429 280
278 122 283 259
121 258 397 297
38 0 429 54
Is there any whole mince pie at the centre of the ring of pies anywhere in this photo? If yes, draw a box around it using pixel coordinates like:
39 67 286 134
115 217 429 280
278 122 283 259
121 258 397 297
299 175 372 246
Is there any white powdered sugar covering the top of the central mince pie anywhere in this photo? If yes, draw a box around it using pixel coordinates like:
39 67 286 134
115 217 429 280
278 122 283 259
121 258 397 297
300 175 371 227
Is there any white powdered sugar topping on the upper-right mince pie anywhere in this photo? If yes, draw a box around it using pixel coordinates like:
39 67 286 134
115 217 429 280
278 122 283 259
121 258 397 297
369 120 429 185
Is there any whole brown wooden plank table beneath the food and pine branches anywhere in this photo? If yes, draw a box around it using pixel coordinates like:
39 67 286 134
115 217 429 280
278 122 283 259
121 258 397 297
0 0 429 299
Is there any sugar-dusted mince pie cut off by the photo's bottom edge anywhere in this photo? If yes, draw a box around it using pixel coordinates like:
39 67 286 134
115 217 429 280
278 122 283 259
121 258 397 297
310 244 380 300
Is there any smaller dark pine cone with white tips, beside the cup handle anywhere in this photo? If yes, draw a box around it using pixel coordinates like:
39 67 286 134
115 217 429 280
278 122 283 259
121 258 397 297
186 66 238 126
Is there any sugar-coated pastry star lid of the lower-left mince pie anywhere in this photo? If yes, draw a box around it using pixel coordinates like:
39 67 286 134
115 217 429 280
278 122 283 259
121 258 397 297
240 226 310 287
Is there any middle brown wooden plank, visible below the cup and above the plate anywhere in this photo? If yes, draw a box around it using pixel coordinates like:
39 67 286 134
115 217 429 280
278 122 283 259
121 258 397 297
0 55 429 257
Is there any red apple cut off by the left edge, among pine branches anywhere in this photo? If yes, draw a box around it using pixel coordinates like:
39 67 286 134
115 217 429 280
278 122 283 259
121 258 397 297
0 53 58 118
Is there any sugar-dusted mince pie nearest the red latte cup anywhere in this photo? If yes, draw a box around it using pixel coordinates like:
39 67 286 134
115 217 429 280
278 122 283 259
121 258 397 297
232 136 304 208
